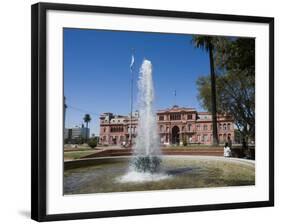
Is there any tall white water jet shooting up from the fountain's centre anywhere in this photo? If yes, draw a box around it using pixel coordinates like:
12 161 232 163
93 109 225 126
131 60 161 173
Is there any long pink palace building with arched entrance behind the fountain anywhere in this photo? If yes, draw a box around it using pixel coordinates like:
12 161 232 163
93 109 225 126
99 106 234 145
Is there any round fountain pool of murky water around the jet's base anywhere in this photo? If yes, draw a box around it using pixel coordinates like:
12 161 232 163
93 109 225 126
64 156 255 194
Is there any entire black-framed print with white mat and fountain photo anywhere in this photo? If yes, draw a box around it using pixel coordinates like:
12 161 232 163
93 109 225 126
31 3 274 221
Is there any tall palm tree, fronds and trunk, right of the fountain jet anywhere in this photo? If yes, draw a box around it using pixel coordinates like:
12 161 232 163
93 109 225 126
192 35 219 145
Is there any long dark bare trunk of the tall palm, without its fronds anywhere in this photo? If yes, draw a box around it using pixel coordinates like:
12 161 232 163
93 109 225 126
209 44 219 145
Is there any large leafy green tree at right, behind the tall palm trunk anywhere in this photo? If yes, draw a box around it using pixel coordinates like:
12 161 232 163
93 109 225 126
197 38 255 140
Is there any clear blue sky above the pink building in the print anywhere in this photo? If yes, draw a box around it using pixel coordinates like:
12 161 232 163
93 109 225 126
64 28 209 135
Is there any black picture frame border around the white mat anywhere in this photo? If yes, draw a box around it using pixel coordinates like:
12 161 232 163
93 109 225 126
31 3 274 221
